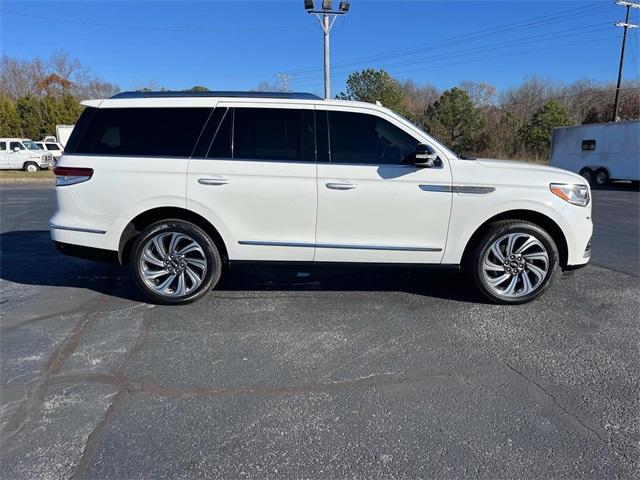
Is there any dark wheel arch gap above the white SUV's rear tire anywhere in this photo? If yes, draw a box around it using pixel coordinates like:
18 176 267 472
118 207 229 264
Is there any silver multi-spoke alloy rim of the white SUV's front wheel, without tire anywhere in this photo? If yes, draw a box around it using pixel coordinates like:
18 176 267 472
482 233 549 298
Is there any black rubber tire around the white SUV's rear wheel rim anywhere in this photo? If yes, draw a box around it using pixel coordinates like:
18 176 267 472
129 219 222 305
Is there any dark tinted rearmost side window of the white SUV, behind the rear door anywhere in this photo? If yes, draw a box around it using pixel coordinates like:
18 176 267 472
66 108 211 157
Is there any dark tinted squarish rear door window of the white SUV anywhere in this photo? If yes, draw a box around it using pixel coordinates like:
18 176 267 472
233 108 303 160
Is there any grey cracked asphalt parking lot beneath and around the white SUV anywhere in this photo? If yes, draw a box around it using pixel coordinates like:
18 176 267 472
0 185 640 479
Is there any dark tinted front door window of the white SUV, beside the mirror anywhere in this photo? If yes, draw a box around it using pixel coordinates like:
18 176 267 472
329 112 419 164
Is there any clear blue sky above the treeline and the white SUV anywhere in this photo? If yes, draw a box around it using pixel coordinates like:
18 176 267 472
0 0 639 94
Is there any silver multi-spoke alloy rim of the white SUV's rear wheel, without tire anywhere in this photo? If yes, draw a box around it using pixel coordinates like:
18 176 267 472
138 232 207 297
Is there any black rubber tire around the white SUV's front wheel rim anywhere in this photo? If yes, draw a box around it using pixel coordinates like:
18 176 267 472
465 220 559 305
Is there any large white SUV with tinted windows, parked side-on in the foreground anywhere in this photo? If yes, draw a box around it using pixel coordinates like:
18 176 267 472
50 92 592 304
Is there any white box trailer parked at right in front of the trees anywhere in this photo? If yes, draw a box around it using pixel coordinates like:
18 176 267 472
549 120 640 185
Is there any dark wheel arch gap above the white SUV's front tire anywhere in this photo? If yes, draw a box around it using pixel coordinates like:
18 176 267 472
462 210 569 268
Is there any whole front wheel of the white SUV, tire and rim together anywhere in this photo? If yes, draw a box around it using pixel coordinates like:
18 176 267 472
469 220 559 305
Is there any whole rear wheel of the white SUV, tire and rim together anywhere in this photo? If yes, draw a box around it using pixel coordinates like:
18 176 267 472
129 219 222 305
